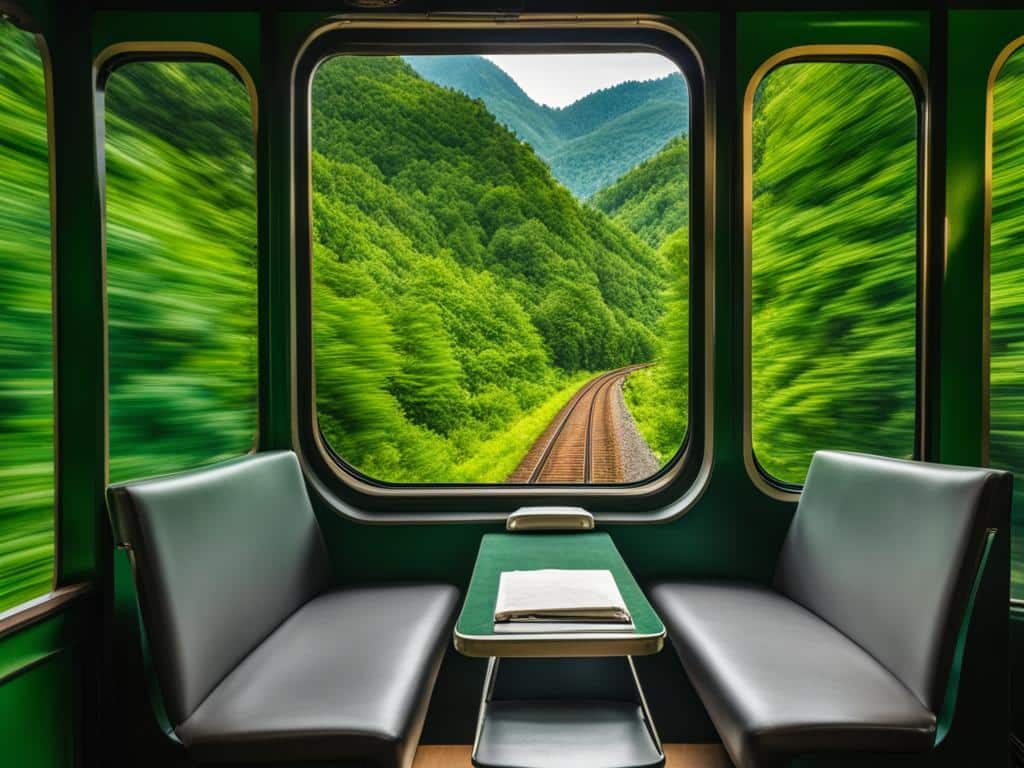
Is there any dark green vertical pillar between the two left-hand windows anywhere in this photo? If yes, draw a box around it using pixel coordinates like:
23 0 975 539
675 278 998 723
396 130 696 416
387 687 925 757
47 0 110 586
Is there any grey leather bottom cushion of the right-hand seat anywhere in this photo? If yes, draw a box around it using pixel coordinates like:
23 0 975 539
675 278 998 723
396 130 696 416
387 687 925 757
650 583 935 768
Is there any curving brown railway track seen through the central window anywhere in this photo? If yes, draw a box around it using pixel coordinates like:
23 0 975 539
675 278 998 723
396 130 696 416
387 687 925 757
508 364 650 483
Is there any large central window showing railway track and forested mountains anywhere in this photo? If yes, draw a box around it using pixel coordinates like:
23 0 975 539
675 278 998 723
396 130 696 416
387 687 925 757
311 53 690 483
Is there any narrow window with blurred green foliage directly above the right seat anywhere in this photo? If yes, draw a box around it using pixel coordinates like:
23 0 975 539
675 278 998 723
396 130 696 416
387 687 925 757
750 61 920 485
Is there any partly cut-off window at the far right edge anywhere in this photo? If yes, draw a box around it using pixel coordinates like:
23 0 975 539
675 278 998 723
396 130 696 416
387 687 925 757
989 50 1024 599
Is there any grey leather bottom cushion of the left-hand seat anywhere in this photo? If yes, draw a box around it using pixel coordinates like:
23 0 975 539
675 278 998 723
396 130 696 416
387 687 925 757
175 585 459 767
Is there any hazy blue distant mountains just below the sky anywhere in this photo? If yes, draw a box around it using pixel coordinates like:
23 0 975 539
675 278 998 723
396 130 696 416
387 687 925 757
406 55 689 199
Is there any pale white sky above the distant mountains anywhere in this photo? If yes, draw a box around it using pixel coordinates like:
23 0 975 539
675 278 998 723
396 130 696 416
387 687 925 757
485 53 679 106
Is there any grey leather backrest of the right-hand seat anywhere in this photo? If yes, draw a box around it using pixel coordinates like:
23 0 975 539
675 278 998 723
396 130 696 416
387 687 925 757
775 451 1013 713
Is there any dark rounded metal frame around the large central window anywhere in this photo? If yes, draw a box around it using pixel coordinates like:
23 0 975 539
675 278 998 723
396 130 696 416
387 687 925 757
292 14 714 523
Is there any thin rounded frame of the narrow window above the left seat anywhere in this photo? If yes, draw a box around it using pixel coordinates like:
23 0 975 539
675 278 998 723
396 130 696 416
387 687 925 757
93 41 265 484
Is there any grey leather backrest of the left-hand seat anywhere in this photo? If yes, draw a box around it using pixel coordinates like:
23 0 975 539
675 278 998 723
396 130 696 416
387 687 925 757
106 452 329 726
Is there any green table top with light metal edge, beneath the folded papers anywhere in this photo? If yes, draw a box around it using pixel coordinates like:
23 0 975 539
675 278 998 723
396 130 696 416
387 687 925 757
456 532 665 656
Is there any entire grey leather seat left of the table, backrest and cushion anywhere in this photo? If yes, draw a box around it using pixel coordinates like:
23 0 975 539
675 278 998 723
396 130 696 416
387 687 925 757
108 452 459 768
